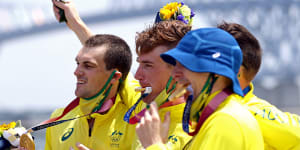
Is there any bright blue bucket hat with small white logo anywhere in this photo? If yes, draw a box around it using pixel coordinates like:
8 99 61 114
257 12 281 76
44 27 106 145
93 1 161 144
160 28 243 96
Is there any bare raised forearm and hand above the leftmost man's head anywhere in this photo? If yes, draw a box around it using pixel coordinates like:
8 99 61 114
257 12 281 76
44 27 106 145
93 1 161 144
52 0 93 45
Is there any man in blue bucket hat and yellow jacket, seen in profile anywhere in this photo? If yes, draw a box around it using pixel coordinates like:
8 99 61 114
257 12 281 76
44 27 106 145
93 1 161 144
161 28 263 150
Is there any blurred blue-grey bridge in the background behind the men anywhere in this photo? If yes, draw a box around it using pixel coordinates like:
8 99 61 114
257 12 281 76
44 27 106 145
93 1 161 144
0 0 300 107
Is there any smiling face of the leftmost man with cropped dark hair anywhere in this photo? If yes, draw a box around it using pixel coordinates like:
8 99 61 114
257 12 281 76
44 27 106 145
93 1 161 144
74 46 112 98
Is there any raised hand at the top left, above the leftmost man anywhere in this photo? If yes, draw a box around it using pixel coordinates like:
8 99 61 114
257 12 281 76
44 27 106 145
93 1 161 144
52 0 82 30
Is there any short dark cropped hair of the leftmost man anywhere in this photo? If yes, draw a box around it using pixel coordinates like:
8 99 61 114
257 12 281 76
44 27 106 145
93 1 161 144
84 34 132 80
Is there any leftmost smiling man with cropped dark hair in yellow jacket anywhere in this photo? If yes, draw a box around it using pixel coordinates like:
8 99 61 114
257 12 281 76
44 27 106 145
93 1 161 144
45 34 140 150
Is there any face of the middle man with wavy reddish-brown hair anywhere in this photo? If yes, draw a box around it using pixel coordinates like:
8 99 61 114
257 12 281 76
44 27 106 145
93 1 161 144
135 46 173 103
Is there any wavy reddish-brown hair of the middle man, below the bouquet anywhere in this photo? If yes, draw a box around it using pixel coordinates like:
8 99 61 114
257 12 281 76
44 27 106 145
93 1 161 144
135 20 191 55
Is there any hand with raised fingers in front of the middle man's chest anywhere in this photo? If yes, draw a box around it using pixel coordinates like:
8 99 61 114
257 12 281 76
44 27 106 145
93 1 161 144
136 102 170 148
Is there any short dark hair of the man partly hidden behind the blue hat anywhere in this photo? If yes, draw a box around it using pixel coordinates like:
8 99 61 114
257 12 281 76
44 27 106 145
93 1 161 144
218 22 262 81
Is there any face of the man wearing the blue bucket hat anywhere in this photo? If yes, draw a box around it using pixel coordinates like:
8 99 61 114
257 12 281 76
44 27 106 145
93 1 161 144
172 61 209 96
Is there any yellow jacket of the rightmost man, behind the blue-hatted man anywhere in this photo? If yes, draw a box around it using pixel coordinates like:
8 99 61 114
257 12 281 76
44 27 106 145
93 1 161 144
247 97 300 150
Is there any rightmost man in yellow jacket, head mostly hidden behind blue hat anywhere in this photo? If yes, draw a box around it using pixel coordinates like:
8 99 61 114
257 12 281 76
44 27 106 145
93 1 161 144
218 22 300 150
